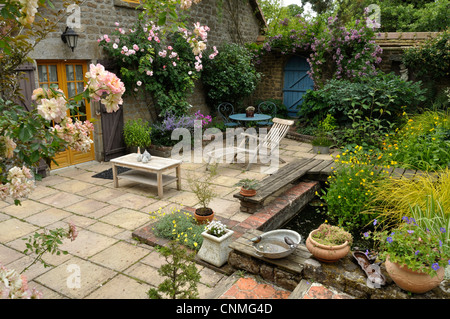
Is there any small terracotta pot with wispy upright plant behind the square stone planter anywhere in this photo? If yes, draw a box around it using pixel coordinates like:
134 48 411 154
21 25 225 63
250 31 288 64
187 171 216 224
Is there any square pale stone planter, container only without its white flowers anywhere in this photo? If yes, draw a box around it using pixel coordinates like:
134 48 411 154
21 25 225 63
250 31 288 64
197 229 234 267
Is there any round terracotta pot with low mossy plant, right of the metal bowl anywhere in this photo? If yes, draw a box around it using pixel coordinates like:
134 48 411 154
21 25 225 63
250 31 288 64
305 223 353 262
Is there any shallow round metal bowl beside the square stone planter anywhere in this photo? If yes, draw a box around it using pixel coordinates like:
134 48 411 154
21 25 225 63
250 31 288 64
252 229 302 259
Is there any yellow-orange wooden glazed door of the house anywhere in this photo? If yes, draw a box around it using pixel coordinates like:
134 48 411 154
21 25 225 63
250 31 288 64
37 61 95 169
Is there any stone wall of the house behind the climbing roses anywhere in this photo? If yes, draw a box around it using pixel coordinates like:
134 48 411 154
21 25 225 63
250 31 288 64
30 0 265 160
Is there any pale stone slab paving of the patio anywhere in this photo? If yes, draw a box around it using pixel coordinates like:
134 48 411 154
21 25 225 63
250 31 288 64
0 138 338 299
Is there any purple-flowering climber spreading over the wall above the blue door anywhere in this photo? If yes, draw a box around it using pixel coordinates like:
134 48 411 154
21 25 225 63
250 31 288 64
252 15 383 87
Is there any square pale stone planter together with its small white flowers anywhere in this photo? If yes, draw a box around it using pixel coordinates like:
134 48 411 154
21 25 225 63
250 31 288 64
197 220 234 267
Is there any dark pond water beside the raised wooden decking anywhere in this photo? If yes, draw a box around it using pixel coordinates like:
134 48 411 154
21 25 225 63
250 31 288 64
280 200 369 250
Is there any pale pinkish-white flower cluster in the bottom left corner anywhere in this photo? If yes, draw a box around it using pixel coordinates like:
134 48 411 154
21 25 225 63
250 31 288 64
0 265 42 299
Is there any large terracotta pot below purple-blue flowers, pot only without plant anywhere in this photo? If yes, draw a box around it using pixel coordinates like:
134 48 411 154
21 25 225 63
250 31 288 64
385 257 445 294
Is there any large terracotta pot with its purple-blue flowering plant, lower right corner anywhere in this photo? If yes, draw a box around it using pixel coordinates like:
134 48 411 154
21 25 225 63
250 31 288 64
365 216 450 293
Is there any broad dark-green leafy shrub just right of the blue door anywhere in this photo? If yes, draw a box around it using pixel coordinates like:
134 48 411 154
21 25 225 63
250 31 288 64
299 73 425 147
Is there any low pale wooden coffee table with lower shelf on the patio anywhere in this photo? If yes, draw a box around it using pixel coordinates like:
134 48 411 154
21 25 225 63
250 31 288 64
110 153 182 198
